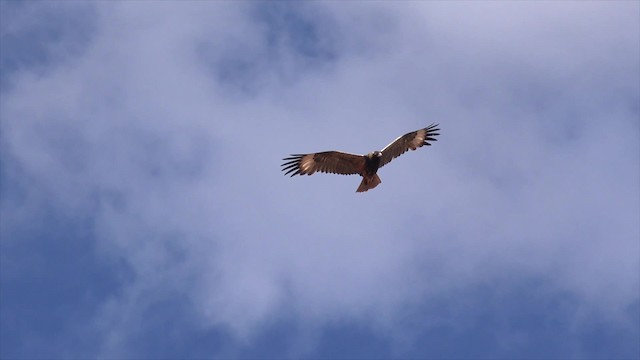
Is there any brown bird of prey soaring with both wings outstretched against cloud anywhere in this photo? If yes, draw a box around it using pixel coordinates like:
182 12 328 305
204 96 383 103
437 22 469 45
282 124 440 192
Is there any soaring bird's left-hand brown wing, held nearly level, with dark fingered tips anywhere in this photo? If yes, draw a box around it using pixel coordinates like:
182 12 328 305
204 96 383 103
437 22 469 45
282 151 365 176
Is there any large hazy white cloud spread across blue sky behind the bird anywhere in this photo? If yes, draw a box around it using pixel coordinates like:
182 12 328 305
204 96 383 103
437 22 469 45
1 2 640 356
